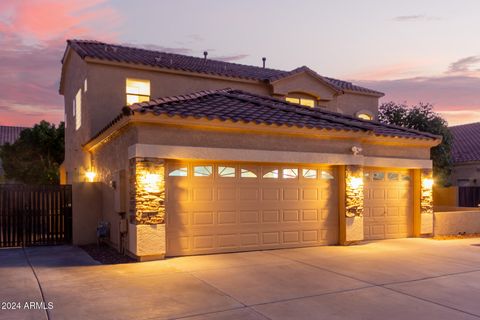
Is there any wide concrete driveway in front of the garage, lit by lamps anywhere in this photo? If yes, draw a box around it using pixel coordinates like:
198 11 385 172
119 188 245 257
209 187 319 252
0 239 480 320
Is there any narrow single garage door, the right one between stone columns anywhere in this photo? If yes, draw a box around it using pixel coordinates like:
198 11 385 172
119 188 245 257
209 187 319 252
363 168 413 239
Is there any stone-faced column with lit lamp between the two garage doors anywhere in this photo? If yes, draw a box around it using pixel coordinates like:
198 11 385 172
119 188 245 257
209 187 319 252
338 165 364 245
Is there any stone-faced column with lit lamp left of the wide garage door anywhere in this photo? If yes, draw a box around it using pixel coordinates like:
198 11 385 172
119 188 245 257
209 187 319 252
129 158 166 261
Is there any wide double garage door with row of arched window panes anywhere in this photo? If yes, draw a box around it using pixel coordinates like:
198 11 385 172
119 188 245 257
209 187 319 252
166 161 338 256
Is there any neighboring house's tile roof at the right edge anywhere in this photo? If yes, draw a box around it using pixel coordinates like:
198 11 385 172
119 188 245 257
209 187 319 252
449 122 480 163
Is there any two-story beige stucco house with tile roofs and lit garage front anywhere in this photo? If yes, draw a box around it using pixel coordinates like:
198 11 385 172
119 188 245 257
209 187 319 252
60 40 440 259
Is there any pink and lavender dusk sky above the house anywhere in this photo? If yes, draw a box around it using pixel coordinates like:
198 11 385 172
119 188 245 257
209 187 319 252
0 0 480 126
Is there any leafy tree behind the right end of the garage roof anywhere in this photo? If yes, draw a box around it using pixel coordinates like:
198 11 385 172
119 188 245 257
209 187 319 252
378 102 453 185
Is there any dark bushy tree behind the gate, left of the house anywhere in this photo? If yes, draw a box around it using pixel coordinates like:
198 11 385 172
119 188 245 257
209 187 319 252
0 121 65 184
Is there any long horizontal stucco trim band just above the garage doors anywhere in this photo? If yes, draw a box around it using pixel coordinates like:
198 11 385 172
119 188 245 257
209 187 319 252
128 144 432 169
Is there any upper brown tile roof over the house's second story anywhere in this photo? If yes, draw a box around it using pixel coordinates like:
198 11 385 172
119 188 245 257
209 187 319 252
62 40 384 96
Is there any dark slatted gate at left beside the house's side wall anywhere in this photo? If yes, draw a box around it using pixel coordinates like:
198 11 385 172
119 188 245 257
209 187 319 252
0 184 72 247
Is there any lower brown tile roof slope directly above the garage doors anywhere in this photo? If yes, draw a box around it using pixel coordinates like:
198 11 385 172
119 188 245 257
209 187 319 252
130 89 439 140
